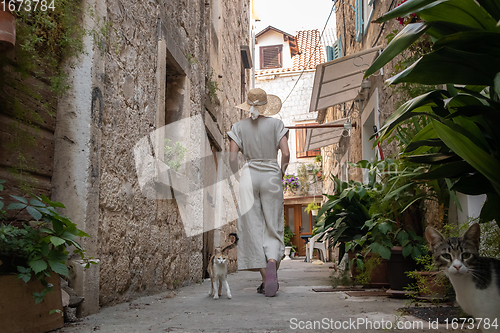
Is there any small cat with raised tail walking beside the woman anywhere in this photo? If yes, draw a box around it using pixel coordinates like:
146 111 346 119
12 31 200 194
208 233 238 299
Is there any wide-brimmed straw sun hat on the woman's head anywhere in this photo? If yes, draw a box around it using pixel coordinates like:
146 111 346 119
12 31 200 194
236 88 281 119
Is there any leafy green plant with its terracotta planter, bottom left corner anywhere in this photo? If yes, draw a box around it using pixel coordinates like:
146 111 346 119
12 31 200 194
0 181 88 331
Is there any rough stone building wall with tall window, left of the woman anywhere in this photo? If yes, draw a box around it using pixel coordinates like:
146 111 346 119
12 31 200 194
53 0 249 315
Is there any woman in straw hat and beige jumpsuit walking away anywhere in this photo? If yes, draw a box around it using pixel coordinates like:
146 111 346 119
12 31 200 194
227 88 290 297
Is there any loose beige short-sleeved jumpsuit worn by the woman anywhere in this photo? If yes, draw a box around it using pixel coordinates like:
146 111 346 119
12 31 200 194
227 117 288 270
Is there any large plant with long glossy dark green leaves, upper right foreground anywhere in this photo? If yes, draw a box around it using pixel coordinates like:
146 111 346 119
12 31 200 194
365 0 500 226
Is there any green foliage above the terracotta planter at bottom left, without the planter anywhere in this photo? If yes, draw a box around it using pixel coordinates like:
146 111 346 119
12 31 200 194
0 184 90 303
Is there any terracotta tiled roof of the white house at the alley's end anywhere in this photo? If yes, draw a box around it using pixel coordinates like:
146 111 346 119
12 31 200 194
255 29 325 75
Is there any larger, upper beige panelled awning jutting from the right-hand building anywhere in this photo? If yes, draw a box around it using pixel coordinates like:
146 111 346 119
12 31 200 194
309 46 382 111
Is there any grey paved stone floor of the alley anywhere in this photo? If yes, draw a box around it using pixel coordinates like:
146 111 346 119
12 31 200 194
56 260 476 333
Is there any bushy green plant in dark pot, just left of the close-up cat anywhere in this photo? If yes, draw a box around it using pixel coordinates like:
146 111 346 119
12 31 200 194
354 159 429 290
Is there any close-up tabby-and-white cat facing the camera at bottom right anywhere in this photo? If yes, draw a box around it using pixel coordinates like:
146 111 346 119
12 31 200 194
425 223 500 332
